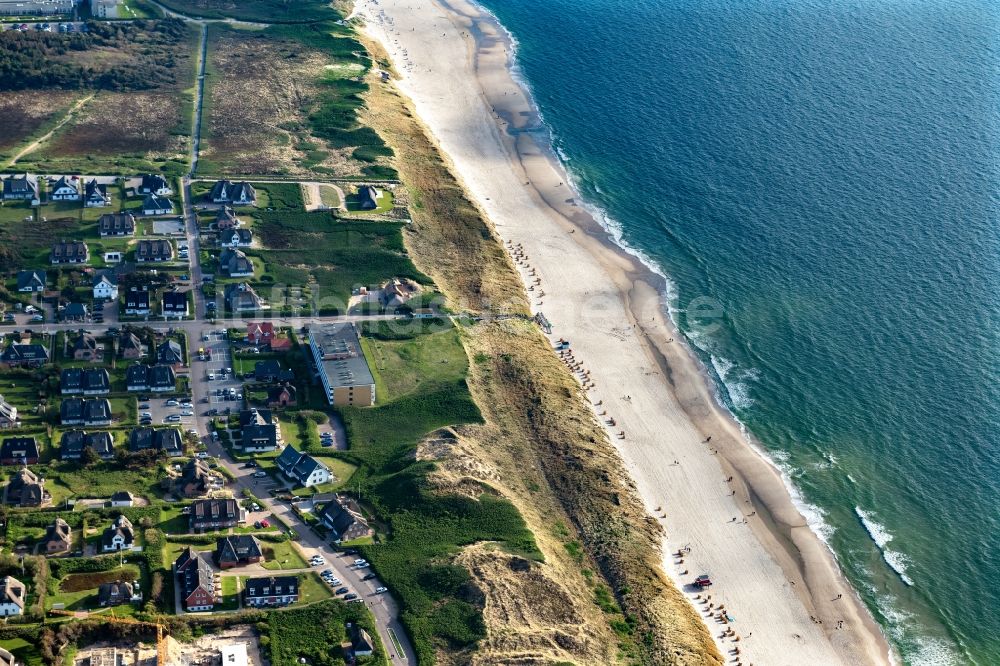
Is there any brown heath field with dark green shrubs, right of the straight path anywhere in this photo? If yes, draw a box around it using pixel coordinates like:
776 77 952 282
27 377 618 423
199 23 391 177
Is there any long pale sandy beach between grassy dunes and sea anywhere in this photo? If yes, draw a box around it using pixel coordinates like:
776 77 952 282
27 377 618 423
356 0 890 665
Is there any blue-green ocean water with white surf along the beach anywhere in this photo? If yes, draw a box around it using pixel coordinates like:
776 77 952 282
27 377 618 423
474 0 1000 665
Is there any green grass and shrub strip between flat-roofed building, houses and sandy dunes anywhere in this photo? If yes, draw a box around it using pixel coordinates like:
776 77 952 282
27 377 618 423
330 322 540 659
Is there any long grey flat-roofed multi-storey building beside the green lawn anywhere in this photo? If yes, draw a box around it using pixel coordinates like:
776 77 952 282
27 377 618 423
309 322 375 406
